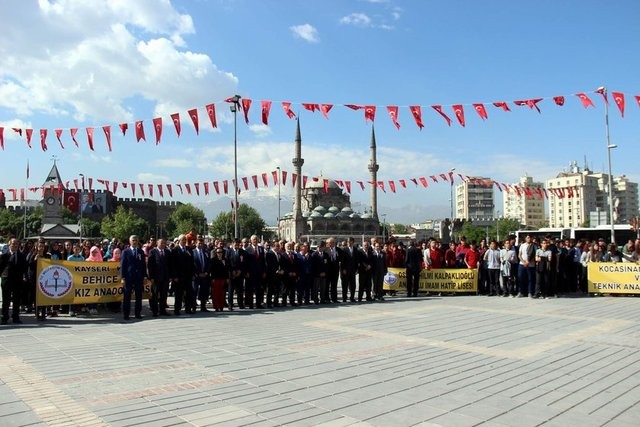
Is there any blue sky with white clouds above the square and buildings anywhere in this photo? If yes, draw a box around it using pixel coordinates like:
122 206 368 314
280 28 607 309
0 0 640 221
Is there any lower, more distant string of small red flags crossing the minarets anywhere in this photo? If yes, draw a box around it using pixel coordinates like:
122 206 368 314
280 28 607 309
0 170 578 205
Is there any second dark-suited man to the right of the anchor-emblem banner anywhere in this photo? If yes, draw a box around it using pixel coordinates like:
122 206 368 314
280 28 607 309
147 239 172 317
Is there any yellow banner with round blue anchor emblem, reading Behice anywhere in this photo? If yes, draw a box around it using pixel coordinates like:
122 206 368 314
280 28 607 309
36 258 151 305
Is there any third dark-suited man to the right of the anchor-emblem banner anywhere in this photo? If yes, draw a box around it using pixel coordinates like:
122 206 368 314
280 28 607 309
171 234 196 316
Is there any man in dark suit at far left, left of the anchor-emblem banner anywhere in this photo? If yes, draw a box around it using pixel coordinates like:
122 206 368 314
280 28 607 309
0 239 27 325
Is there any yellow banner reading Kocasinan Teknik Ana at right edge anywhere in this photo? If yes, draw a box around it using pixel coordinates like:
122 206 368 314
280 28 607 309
587 262 640 294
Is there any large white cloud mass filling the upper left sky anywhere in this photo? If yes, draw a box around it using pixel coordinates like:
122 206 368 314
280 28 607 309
0 0 238 122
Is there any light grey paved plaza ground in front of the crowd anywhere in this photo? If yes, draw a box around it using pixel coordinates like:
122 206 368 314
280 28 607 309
0 296 640 427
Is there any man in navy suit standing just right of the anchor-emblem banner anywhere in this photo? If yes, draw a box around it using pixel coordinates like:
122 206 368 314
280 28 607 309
120 235 147 320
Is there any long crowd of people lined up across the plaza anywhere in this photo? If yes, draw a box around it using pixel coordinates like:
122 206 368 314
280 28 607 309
0 232 640 324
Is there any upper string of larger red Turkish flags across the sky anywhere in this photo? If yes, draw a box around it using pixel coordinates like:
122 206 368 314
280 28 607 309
0 87 640 151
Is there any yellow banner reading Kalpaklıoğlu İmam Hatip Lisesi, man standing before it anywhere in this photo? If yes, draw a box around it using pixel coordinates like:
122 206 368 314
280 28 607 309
383 268 478 293
